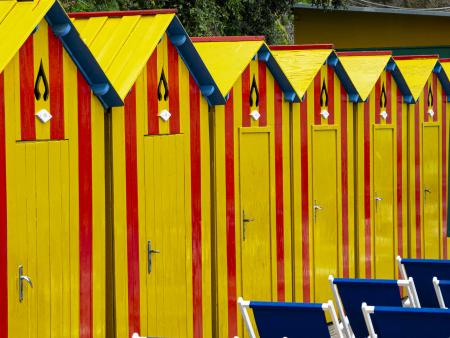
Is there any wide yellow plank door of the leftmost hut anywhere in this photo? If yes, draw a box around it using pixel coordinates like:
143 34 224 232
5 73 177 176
8 141 71 338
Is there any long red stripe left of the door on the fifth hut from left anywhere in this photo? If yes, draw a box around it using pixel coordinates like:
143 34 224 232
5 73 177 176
364 99 376 278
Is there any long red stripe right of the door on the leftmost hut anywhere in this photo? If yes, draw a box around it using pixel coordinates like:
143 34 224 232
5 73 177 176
77 72 94 338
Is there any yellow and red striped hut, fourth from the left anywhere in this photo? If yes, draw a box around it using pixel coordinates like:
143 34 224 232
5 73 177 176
271 45 359 302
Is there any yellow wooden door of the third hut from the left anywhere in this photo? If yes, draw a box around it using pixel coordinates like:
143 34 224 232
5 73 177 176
239 129 273 301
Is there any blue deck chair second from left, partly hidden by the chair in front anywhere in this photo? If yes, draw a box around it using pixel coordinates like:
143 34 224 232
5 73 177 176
328 276 420 338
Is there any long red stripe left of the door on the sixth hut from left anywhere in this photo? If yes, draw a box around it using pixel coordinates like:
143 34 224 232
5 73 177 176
414 100 425 258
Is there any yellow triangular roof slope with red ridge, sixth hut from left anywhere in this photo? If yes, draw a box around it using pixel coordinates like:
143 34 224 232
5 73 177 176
394 55 438 101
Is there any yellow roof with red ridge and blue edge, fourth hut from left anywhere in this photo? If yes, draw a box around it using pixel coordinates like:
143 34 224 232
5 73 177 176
270 45 359 102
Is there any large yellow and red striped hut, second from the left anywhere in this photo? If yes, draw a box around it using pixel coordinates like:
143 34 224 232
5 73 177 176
71 10 225 337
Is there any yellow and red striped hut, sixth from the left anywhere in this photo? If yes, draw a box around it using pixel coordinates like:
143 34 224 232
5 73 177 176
394 55 449 258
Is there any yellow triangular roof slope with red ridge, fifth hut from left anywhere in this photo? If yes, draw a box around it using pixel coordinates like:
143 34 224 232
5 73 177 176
338 52 392 101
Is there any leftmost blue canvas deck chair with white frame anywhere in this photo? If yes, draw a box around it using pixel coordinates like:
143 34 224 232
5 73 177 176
238 297 344 338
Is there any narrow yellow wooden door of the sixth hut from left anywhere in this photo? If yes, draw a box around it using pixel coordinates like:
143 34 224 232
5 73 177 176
422 124 441 258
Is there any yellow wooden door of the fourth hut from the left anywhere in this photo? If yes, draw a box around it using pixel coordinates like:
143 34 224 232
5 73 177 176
312 127 341 302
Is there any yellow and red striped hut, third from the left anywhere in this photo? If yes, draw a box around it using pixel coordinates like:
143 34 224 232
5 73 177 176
193 37 295 337
